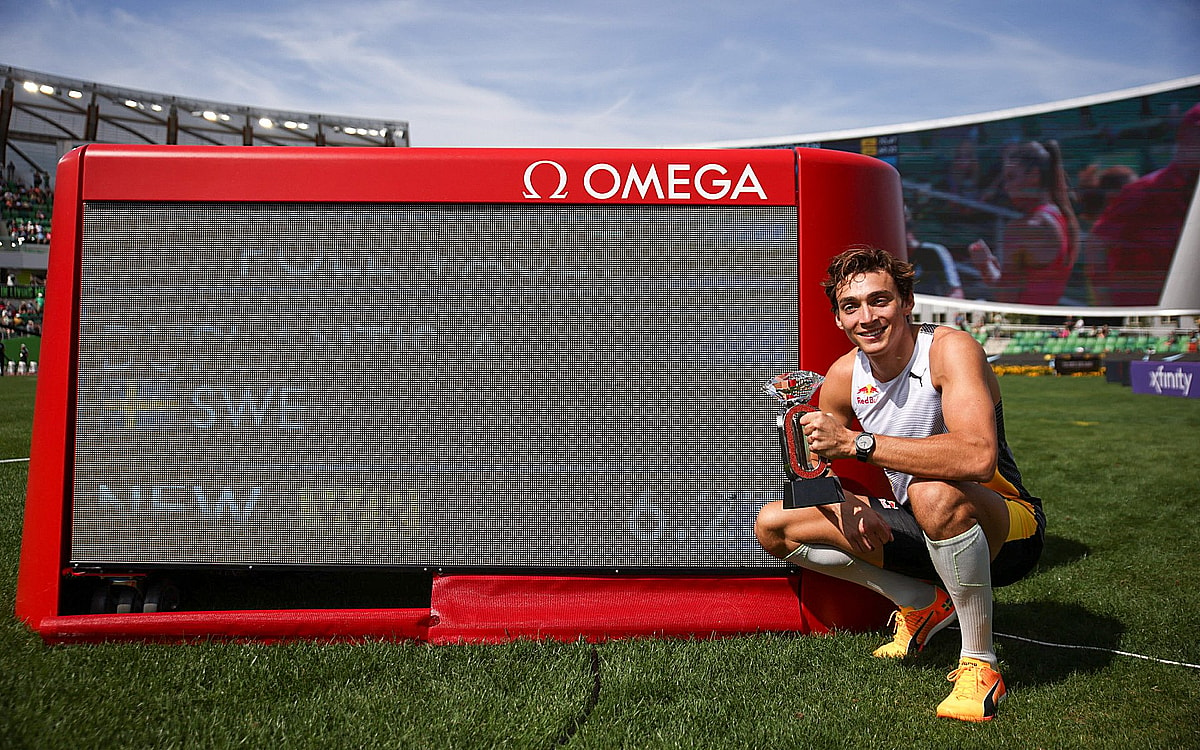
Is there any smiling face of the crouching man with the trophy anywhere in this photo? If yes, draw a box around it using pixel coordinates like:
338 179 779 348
836 271 913 355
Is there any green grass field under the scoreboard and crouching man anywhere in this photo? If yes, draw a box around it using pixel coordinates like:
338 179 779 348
0 377 1200 750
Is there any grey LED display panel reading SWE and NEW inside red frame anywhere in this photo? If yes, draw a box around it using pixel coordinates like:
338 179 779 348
70 202 798 569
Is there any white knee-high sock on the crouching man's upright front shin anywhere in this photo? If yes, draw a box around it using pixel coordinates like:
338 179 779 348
925 523 996 666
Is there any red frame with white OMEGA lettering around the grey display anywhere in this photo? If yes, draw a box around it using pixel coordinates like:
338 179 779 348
17 145 905 642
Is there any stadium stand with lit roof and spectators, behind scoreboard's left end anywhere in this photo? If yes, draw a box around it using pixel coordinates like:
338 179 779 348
0 66 409 345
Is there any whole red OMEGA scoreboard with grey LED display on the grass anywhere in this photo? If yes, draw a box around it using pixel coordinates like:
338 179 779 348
18 145 905 640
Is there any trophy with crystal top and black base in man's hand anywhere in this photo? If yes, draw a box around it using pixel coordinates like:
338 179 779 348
762 370 844 509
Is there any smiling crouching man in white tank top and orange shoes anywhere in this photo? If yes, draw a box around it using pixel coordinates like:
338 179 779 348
755 247 1045 721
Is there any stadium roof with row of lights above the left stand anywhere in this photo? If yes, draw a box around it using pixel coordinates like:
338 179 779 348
0 66 409 174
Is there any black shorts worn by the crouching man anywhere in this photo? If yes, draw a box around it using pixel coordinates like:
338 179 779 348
870 497 1046 588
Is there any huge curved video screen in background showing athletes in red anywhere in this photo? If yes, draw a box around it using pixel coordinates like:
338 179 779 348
790 81 1200 307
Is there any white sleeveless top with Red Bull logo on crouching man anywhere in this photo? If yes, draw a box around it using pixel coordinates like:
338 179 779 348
851 323 946 504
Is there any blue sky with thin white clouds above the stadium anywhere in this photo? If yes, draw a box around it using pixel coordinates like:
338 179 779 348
0 0 1200 146
